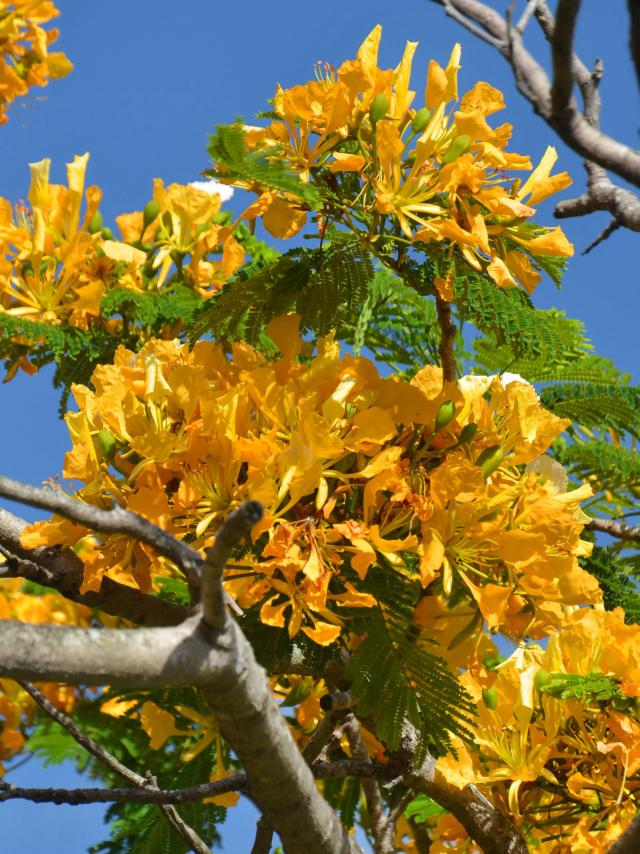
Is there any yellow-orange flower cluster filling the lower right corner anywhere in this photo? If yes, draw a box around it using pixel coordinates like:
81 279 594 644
420 608 640 854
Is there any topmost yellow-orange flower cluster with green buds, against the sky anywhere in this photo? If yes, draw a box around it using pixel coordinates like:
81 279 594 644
216 26 573 299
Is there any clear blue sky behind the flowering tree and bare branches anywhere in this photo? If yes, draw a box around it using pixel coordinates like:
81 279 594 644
0 0 640 854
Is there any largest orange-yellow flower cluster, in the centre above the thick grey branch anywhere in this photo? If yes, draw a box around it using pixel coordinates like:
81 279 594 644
23 315 601 648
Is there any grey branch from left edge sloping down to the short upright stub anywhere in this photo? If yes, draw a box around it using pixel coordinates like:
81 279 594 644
0 476 203 589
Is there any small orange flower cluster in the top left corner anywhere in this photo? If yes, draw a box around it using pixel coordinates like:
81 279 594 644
0 0 73 125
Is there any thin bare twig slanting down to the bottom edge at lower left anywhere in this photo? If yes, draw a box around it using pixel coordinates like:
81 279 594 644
19 680 211 854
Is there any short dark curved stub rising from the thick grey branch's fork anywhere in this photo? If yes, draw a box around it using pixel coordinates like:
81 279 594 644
201 501 264 629
